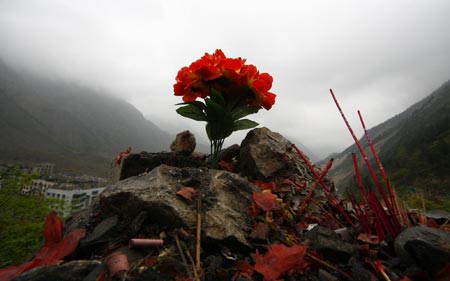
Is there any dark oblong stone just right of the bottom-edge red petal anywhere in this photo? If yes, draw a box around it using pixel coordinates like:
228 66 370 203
305 225 355 264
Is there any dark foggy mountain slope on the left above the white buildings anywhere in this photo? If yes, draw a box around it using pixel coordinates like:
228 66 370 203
0 62 173 175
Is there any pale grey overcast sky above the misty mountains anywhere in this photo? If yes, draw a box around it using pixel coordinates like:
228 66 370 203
0 0 450 157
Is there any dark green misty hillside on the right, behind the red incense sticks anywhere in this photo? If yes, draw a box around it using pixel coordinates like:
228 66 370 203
330 81 450 209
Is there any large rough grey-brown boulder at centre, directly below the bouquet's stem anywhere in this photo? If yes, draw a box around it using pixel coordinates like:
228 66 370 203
99 165 256 245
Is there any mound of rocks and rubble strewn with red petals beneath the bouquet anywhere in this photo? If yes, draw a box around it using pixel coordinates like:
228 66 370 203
5 128 450 281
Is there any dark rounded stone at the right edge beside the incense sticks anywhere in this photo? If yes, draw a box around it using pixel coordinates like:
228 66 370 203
394 226 450 274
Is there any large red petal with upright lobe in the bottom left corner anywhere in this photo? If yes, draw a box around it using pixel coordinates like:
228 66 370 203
0 212 86 281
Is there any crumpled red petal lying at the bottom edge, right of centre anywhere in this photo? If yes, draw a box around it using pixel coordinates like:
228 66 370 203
254 244 306 281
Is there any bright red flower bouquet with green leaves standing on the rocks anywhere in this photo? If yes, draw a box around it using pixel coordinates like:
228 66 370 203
173 49 276 168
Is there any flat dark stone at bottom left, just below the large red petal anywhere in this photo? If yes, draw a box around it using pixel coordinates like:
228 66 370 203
12 260 101 281
